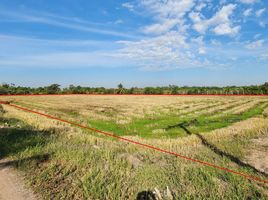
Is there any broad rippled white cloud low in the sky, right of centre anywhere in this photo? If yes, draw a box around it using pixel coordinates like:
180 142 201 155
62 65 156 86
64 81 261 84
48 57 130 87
118 31 232 71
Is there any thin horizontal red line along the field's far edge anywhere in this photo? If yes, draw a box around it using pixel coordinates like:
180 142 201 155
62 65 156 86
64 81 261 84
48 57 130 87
0 94 268 97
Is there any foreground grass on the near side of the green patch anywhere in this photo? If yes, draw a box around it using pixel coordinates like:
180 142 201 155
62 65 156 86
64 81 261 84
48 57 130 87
0 104 268 200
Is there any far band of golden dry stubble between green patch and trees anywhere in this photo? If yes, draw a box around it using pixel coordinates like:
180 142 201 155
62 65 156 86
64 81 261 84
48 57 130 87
2 95 267 120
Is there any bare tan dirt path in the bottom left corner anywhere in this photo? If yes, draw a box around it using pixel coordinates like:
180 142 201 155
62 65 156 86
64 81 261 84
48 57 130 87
0 160 40 200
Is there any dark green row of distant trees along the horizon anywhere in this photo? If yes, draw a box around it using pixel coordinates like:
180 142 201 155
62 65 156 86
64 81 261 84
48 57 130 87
0 82 268 95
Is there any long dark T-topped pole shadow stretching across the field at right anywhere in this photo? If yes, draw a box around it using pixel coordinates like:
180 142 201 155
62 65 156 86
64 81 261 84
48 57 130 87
166 120 268 177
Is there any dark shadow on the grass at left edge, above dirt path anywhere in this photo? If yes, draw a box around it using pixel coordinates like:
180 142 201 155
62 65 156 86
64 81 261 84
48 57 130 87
0 116 50 168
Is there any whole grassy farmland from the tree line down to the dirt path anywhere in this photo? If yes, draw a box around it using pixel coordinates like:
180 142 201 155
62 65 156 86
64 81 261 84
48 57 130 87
0 95 268 199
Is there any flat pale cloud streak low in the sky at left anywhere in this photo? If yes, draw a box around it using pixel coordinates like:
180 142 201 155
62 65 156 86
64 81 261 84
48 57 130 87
0 51 129 68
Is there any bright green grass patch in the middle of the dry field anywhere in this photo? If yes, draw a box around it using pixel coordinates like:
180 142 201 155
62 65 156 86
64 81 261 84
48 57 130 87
88 104 268 138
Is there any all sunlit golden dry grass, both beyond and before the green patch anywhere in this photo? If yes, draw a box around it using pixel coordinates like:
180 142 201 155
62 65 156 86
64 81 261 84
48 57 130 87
0 96 268 199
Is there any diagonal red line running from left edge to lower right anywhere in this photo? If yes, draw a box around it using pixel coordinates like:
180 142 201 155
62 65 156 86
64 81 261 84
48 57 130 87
0 101 268 184
